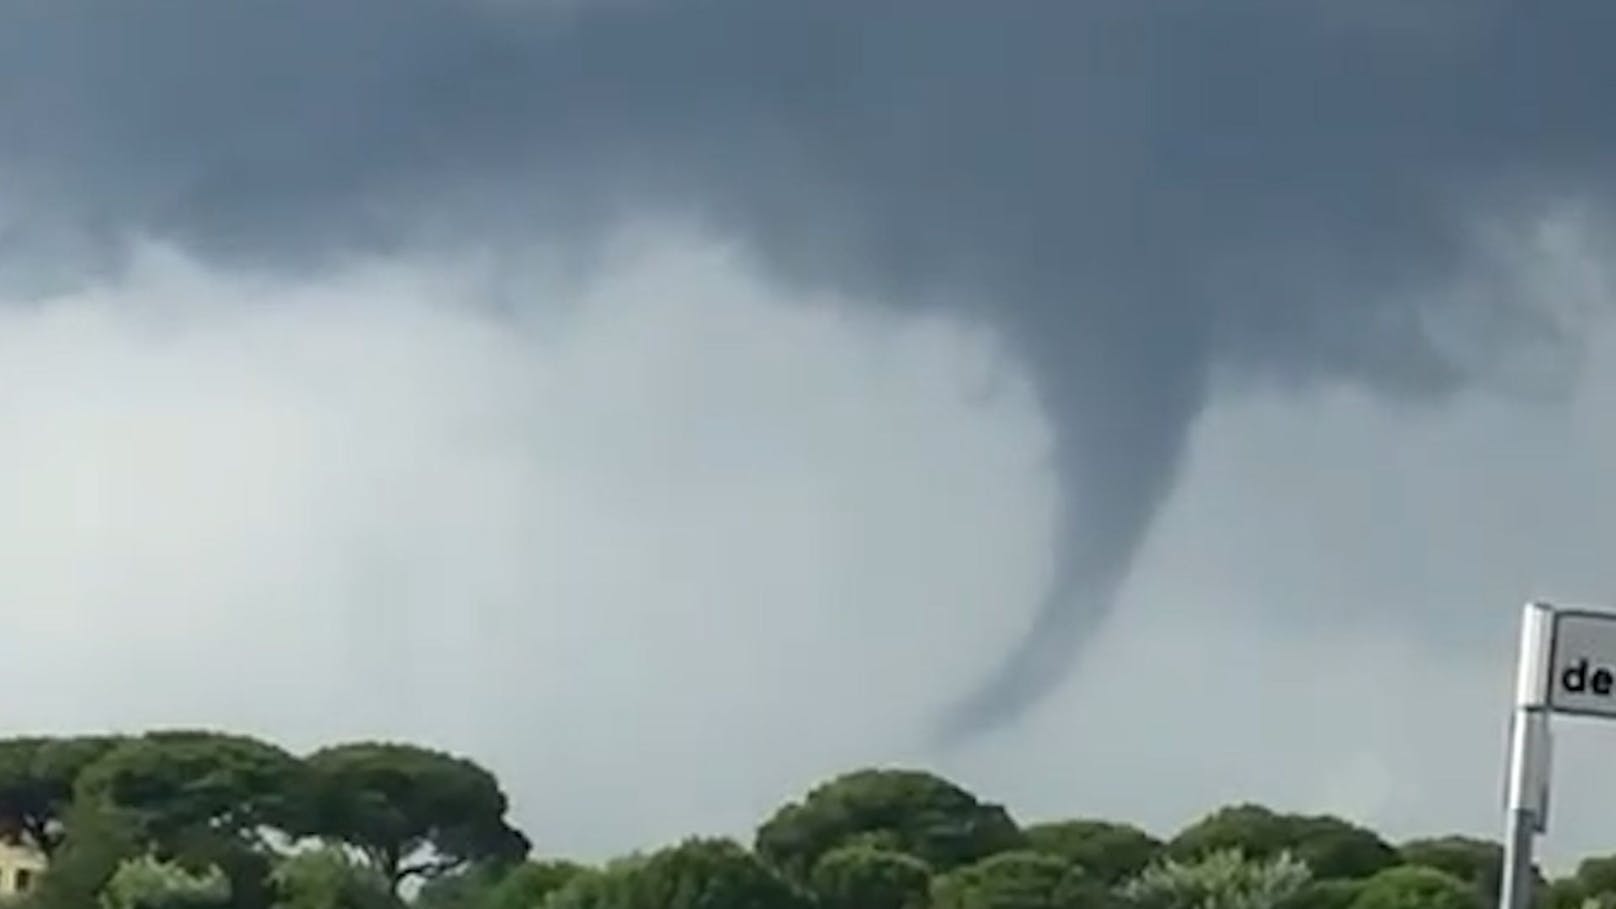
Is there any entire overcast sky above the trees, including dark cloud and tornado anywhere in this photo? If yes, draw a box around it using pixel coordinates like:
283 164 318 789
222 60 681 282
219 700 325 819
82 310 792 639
0 0 1616 860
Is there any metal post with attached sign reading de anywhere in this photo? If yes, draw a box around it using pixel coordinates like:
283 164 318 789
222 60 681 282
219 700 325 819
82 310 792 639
1498 603 1616 909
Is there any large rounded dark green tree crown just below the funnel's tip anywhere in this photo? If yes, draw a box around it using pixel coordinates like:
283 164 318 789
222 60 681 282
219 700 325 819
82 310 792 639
756 770 1023 882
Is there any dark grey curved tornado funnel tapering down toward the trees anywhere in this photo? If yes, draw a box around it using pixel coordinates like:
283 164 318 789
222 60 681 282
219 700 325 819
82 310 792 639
934 286 1209 749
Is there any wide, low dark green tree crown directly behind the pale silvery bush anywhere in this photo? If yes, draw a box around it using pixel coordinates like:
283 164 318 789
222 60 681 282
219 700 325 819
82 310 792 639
1167 804 1398 878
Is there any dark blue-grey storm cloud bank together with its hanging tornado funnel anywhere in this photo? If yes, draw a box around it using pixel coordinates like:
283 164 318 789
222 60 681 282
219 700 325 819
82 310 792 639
0 0 1616 734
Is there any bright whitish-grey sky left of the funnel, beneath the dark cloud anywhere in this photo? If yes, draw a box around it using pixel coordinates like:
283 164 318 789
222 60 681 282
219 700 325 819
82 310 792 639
0 230 1049 859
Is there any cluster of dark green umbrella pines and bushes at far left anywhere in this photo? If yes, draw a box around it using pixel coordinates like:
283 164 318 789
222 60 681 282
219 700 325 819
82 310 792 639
0 729 530 909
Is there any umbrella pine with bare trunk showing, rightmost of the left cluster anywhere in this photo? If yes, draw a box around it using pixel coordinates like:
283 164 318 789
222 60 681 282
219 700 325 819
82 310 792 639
299 742 528 893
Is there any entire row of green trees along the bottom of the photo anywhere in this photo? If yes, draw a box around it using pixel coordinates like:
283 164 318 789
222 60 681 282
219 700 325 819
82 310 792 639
0 731 1616 909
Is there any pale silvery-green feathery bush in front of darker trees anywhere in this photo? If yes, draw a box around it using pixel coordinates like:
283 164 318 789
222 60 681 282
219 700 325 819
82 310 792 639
1122 849 1312 909
